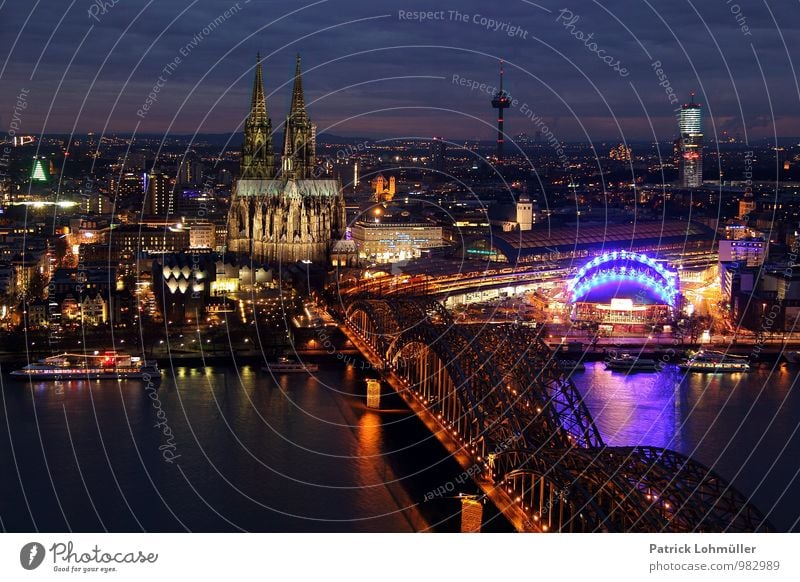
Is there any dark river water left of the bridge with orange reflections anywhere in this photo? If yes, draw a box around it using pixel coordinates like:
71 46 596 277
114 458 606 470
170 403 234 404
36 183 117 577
0 362 441 531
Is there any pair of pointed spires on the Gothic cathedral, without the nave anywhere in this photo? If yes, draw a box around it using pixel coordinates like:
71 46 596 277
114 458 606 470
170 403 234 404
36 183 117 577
241 55 316 180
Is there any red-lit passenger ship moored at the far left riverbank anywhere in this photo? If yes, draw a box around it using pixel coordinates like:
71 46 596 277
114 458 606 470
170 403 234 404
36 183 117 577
11 351 161 381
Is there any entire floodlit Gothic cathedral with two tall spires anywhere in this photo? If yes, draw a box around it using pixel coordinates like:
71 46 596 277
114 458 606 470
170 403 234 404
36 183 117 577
227 55 345 264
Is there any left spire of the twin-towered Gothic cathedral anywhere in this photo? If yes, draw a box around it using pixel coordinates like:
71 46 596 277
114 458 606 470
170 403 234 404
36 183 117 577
240 54 275 179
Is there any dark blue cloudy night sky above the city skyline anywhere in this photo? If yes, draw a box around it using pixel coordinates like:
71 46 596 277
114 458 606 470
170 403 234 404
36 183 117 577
0 0 800 142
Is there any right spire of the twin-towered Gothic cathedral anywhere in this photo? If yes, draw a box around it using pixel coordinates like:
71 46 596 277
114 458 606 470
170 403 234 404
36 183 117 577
281 54 317 180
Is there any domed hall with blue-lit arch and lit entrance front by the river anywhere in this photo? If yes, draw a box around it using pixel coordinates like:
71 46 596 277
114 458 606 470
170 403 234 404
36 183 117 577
567 250 680 324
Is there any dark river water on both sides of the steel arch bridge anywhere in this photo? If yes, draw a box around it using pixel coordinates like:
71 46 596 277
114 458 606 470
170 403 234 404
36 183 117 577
0 357 800 532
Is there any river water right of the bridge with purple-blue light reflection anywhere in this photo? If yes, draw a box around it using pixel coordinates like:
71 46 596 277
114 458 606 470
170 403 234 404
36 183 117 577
572 362 800 531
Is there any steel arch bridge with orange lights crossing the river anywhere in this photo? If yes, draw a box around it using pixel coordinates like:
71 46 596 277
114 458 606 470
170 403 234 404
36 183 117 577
345 298 772 532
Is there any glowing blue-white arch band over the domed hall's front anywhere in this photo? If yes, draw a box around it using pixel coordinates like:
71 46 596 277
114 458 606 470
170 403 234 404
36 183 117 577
569 251 678 307
